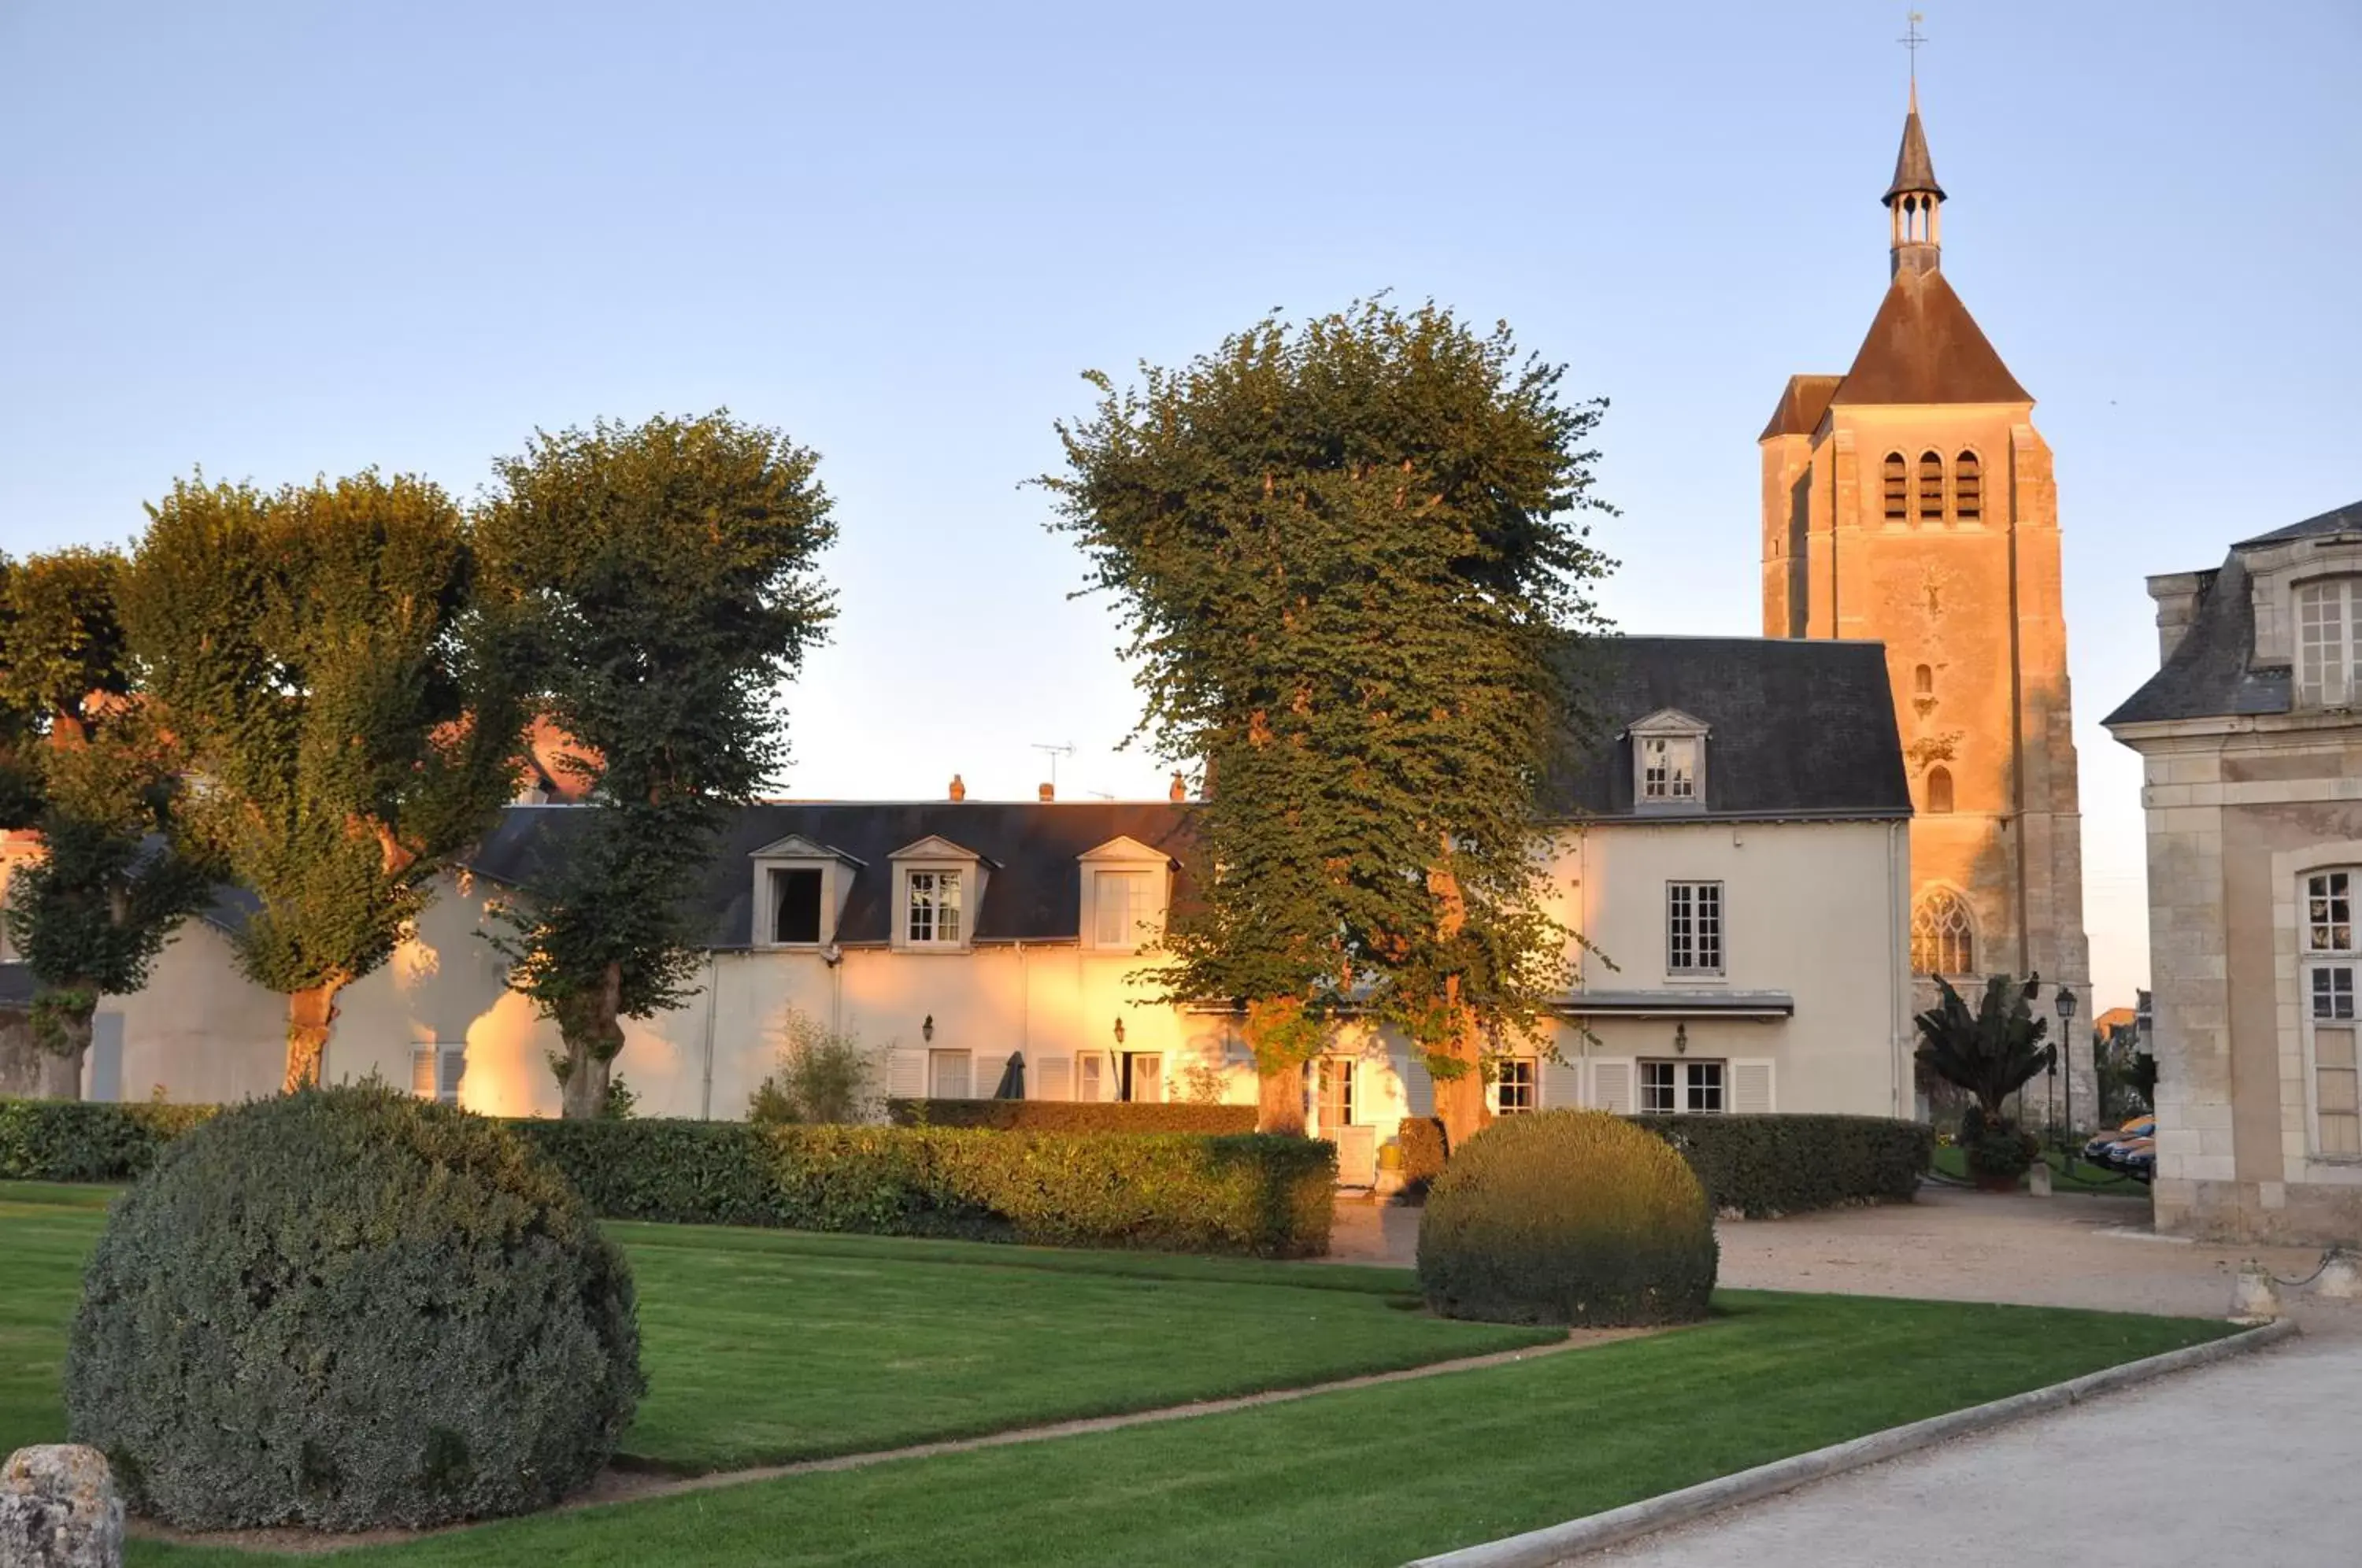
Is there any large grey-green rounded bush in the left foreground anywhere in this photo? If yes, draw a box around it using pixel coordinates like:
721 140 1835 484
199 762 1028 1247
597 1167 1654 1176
66 1084 645 1530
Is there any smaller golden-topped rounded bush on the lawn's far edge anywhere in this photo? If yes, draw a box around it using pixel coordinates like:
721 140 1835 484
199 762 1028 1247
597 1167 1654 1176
1420 1110 1717 1327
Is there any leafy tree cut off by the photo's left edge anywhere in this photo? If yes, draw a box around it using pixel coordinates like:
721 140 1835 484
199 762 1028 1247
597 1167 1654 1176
0 550 208 1100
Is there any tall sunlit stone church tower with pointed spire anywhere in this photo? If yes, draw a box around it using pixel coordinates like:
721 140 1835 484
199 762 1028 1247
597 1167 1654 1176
1762 87 2095 1100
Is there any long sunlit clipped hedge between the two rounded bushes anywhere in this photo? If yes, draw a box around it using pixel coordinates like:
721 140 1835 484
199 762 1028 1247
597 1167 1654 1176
515 1119 1337 1256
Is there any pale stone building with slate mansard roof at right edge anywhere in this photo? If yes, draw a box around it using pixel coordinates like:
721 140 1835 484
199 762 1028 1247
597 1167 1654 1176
2105 501 2362 1242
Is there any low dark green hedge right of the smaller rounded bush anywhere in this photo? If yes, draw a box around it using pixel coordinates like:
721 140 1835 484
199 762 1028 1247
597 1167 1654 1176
1630 1112 1934 1219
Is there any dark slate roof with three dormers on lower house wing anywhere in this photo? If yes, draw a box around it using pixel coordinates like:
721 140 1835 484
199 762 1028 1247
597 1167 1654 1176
468 801 1188 947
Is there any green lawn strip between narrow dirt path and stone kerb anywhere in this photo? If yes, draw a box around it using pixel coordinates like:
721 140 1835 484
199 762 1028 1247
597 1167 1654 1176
130 1292 2225 1568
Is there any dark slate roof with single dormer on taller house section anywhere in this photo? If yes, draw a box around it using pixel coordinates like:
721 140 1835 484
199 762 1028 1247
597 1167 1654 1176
1545 638 1911 822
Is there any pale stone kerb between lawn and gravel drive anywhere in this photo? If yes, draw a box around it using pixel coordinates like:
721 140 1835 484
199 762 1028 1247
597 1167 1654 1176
1405 1318 2296 1568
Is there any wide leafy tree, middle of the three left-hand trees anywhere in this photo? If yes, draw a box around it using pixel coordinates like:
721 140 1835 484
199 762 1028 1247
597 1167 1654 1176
123 472 522 1089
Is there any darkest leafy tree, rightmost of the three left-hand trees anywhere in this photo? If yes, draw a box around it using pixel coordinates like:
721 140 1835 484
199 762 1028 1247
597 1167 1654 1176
479 413 836 1119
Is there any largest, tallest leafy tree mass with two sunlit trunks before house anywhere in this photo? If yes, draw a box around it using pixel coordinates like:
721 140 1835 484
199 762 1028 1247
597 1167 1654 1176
1042 302 1611 1141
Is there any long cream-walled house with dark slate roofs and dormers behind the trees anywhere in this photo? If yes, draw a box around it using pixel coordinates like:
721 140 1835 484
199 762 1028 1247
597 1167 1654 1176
4 638 1913 1176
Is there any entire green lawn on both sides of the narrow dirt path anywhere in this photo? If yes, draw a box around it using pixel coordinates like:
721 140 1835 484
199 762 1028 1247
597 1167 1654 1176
0 1185 2225 1568
